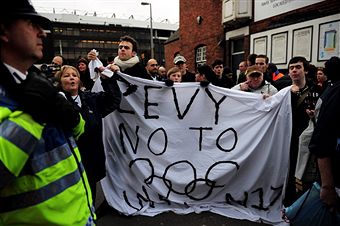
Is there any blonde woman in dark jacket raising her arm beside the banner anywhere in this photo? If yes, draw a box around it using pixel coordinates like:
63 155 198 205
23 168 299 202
56 65 121 201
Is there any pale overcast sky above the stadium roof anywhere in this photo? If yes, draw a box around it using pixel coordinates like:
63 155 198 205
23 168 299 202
31 0 179 23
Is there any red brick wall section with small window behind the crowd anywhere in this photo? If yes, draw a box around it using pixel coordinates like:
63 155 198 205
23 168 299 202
165 0 224 71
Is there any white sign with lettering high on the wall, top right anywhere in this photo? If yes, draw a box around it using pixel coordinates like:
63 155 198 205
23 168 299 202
254 0 325 22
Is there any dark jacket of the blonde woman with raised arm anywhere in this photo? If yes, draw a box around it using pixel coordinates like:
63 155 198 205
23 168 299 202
77 78 121 186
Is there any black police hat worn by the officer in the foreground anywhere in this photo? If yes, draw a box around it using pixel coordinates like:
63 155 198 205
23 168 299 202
0 0 51 30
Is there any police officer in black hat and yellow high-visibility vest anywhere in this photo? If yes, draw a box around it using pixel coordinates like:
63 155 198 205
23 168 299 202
0 0 95 225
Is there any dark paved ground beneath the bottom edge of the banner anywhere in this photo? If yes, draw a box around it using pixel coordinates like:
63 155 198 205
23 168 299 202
96 184 268 226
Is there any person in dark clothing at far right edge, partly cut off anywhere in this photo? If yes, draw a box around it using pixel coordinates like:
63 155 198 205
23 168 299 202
309 57 340 212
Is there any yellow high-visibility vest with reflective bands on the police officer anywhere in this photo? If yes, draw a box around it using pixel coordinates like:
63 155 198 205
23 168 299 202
0 90 95 226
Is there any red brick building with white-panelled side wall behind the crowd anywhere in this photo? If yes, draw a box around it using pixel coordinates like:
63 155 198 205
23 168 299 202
165 0 340 76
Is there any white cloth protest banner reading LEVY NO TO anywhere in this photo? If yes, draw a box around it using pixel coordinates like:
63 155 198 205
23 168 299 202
96 75 291 224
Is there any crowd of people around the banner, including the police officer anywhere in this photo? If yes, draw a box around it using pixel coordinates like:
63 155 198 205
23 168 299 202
0 0 340 225
